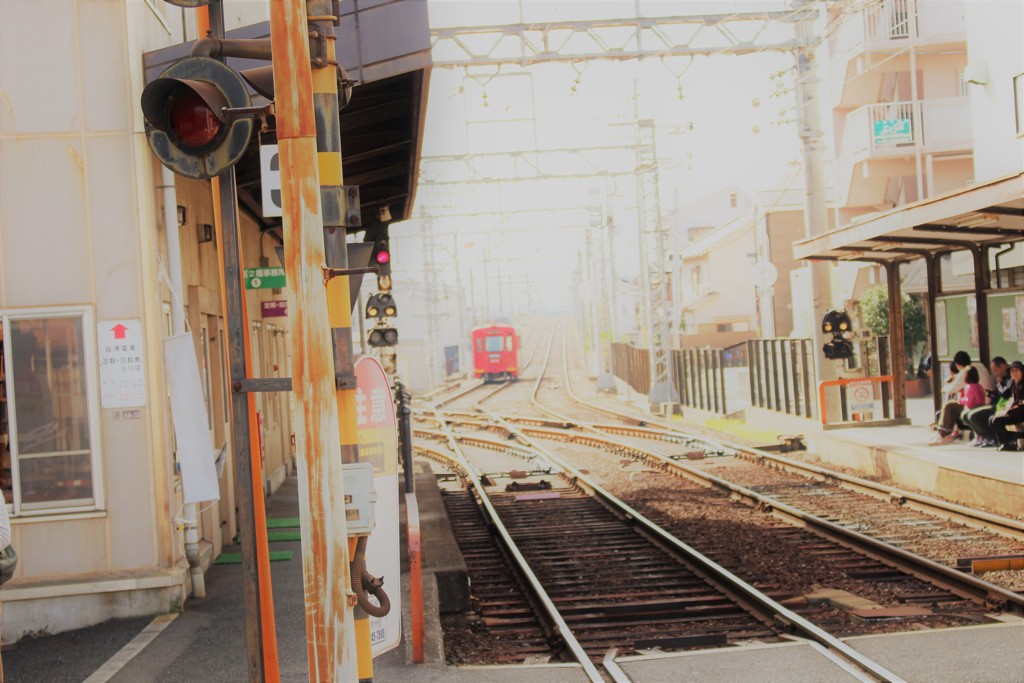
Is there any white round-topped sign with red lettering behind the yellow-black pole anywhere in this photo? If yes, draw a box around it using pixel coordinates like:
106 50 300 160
355 356 401 656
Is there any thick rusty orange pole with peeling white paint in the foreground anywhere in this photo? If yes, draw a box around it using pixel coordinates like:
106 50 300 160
270 0 357 681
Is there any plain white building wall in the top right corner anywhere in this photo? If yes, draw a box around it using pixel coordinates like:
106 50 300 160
967 0 1024 182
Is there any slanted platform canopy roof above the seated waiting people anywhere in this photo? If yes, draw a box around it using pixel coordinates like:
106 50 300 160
793 173 1024 262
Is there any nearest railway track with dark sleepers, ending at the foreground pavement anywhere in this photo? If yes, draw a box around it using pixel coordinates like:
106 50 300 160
417 434 900 681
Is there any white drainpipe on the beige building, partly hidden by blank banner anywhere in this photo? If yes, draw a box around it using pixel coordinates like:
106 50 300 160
160 166 206 598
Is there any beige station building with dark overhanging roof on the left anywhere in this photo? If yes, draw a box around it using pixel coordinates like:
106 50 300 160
0 0 429 642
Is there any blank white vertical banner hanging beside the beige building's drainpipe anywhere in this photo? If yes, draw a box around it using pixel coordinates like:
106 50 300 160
164 332 220 503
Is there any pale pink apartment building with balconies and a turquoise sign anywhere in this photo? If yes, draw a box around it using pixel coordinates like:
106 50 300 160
822 0 970 225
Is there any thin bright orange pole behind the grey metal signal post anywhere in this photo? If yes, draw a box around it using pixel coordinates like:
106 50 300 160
196 7 281 683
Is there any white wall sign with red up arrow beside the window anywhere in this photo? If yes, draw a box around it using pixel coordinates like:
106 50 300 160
96 321 145 409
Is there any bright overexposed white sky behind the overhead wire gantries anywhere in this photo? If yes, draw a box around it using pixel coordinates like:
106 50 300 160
392 0 815 321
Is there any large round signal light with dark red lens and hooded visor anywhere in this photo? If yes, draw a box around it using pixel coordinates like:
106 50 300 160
142 57 254 179
